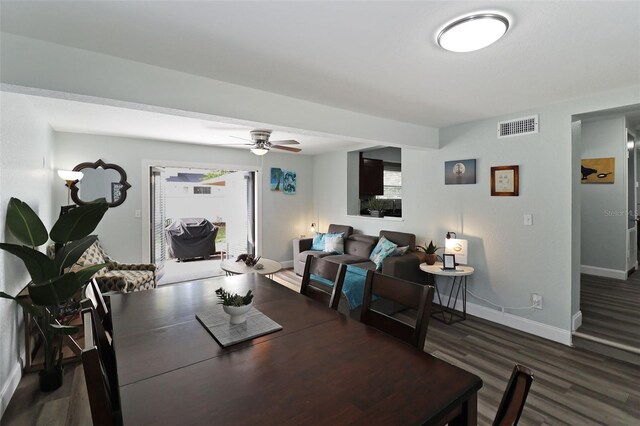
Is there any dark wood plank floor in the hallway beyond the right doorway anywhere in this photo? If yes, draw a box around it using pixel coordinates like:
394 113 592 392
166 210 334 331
577 271 640 350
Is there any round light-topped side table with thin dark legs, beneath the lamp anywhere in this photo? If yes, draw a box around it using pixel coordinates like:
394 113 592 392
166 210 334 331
420 262 474 324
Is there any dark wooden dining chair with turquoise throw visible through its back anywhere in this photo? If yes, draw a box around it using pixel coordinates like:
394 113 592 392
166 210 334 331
300 254 347 310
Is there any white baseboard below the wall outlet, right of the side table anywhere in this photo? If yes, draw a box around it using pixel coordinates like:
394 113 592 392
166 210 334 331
442 295 572 346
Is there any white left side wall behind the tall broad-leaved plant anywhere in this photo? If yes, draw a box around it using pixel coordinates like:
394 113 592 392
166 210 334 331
0 92 57 417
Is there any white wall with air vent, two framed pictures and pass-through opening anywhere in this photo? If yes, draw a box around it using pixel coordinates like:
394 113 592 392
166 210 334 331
314 88 640 344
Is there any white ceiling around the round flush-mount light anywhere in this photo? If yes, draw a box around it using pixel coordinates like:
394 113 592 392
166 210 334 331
0 0 640 127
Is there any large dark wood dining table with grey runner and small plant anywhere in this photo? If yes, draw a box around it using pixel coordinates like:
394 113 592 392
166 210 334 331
111 274 482 425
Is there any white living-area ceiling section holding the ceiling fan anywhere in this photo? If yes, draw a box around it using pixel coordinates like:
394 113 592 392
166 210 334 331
28 95 360 155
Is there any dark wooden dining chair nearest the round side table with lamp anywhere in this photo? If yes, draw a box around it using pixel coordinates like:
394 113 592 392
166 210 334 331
360 271 433 350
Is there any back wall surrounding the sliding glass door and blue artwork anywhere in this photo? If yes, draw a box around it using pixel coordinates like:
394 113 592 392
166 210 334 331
54 133 313 262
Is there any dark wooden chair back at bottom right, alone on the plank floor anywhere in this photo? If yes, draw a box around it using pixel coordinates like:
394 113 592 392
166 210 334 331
493 364 533 426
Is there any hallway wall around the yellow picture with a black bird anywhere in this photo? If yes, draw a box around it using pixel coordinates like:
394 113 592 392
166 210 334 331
580 116 628 277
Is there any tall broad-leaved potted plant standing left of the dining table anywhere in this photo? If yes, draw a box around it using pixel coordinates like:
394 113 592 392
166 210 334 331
0 198 109 391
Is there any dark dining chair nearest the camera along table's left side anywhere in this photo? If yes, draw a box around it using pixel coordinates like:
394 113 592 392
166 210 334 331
81 308 122 426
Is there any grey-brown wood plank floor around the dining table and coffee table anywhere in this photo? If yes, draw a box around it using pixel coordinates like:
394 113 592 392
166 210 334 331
5 270 640 426
